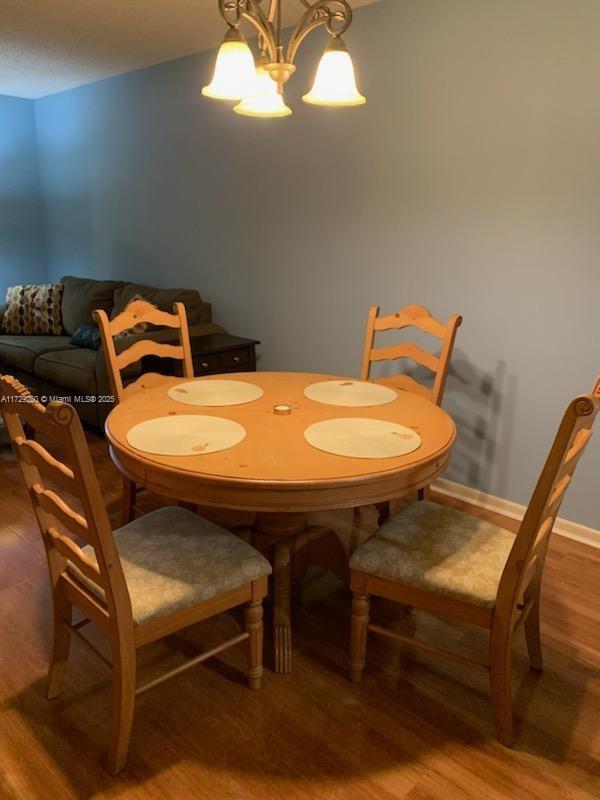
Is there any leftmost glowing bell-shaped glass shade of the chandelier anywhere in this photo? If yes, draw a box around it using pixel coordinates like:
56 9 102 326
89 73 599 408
202 28 256 100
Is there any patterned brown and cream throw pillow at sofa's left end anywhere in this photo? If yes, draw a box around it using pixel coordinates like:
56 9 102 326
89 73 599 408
2 283 63 336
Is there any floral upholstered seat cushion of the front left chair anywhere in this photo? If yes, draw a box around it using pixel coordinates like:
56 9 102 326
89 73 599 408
68 506 271 625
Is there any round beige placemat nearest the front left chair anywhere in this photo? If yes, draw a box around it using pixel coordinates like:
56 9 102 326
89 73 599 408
127 414 246 456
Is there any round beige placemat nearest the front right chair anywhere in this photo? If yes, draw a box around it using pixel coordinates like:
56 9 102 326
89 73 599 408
304 417 421 458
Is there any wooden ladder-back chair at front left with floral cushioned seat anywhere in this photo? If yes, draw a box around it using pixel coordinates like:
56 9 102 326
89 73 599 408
0 376 271 774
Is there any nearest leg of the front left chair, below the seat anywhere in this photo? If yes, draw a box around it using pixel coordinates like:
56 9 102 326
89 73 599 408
108 643 135 775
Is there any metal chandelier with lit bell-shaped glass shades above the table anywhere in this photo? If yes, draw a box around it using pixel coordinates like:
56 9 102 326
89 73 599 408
202 0 367 118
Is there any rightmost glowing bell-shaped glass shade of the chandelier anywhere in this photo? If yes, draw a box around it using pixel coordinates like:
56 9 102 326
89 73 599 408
302 36 367 106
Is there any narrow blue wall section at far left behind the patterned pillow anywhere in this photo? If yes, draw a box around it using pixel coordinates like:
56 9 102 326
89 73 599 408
0 95 46 303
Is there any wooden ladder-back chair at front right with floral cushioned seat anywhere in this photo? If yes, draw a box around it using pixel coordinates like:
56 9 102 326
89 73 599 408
350 378 600 747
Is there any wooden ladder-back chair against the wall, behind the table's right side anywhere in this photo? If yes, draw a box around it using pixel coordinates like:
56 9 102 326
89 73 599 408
356 305 462 524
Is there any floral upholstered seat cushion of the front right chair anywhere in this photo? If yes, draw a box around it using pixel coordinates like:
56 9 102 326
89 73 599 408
350 502 515 608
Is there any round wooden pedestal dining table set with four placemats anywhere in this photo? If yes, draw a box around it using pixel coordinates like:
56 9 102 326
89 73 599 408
106 372 456 673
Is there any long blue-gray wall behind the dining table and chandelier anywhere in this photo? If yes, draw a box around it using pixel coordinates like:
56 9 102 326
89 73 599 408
36 0 600 527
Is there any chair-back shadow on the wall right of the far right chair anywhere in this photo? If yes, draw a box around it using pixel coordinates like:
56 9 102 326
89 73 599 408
444 350 517 497
